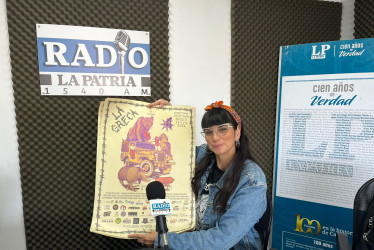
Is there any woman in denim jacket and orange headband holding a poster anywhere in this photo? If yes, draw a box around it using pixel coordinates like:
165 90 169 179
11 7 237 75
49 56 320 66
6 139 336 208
129 99 266 250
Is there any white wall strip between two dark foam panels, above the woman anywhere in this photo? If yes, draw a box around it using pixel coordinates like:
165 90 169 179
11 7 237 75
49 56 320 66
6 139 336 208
169 0 231 145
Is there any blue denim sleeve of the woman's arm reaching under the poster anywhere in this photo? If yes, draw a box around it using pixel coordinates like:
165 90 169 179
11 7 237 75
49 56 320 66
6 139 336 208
156 183 266 250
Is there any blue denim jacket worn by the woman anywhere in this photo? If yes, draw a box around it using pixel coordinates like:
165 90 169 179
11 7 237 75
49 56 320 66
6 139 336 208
155 146 267 250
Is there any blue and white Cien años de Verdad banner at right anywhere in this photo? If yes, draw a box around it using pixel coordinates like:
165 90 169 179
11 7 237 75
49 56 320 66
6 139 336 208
272 39 374 250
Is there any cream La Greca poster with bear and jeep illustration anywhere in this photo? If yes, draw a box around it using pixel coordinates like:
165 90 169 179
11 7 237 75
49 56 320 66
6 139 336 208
90 98 195 239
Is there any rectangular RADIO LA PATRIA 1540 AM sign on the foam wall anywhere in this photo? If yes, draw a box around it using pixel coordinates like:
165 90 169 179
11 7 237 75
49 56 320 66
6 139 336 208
36 24 151 96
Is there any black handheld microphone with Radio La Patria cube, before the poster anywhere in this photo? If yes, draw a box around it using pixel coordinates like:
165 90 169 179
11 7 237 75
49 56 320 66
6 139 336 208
146 181 172 249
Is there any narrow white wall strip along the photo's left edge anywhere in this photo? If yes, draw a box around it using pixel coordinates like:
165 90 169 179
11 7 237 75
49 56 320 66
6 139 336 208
0 0 26 250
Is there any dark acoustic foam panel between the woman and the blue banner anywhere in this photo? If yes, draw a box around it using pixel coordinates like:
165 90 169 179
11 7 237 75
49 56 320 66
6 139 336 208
231 0 342 198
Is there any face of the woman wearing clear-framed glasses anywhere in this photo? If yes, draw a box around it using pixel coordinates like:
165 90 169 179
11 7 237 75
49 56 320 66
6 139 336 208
205 123 240 157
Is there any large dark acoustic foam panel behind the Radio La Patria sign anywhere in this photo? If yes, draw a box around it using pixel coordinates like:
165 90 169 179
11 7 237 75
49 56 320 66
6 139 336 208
6 0 169 249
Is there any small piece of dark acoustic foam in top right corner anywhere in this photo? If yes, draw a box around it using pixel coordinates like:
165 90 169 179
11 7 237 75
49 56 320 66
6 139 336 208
353 0 374 39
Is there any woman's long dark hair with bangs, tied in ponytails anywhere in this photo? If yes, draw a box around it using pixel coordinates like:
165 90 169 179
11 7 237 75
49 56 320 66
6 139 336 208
191 108 254 213
